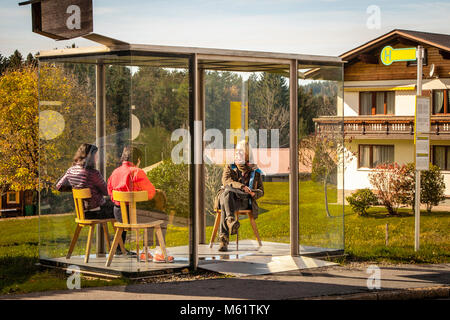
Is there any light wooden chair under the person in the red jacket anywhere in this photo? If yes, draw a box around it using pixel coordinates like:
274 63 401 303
106 191 168 267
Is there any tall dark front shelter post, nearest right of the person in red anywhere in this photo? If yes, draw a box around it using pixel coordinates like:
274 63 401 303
189 54 201 270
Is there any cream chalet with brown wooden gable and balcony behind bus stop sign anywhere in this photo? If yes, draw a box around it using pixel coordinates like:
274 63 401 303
314 30 450 200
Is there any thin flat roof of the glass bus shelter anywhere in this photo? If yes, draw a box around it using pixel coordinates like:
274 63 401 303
38 34 343 73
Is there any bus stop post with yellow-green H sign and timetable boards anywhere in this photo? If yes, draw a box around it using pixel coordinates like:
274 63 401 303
380 45 430 251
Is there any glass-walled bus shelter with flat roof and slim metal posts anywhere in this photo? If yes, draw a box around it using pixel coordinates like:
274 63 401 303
39 35 344 275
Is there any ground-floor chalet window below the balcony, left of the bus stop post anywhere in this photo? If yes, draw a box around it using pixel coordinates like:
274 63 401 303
358 144 394 168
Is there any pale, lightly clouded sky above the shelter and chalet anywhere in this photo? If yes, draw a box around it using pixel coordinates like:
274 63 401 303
0 0 450 56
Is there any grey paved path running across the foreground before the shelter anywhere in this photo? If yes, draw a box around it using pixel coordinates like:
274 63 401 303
0 264 450 300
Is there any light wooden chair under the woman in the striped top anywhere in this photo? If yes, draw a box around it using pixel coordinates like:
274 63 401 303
66 188 123 263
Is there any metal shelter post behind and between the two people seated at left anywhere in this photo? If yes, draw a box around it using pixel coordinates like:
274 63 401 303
95 63 106 257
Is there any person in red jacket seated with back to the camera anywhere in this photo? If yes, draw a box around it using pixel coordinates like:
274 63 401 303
108 146 156 254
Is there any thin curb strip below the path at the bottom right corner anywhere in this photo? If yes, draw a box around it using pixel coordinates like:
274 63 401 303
301 286 450 300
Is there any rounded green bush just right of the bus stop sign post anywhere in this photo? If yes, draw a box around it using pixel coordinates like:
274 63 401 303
420 164 445 212
